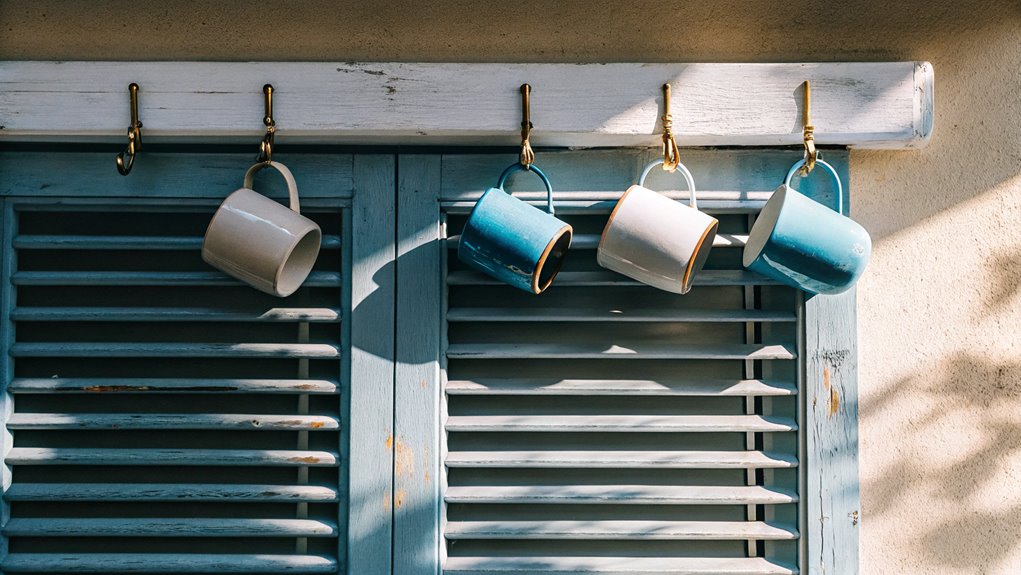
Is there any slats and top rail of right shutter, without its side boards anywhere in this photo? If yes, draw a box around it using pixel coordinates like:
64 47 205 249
410 150 816 575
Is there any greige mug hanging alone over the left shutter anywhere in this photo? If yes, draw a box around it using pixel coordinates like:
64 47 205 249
202 161 323 297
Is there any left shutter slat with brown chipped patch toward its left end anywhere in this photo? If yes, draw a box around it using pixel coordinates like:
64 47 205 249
8 378 340 395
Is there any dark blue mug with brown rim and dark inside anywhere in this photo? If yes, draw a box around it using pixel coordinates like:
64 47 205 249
457 163 574 293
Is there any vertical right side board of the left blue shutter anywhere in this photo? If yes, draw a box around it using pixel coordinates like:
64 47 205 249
351 153 396 573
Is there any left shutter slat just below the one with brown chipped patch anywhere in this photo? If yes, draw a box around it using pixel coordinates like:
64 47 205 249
7 413 340 431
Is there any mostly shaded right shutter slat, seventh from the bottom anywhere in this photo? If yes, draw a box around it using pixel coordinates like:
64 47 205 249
447 340 796 360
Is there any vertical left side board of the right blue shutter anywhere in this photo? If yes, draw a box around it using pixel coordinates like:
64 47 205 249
392 154 443 575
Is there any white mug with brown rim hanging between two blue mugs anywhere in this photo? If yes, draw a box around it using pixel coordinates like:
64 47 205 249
596 159 720 293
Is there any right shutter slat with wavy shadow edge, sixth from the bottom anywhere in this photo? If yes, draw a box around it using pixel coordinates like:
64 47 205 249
446 379 797 397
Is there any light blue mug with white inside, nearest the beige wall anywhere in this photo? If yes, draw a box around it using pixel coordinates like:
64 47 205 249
743 154 872 294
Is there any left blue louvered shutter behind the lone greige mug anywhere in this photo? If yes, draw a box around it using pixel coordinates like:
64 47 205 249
3 154 393 573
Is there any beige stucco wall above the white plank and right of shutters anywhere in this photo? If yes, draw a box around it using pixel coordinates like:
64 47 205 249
0 0 1021 575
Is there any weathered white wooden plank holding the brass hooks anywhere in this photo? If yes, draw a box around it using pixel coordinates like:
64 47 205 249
0 61 932 148
